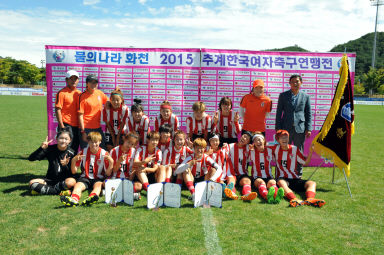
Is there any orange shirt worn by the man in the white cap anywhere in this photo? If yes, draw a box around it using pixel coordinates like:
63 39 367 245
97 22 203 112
55 87 81 127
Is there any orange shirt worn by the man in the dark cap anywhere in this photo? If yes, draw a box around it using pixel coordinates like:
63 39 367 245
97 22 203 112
78 89 108 129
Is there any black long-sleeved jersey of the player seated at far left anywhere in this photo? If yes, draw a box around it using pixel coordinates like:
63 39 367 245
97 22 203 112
28 144 75 182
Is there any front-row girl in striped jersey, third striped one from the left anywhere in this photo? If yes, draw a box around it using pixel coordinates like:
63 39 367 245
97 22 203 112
133 131 165 190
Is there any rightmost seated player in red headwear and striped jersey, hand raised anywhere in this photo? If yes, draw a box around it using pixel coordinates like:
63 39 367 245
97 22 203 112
273 130 325 207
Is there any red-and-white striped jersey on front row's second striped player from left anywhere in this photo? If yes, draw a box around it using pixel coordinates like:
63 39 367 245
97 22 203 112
111 145 136 179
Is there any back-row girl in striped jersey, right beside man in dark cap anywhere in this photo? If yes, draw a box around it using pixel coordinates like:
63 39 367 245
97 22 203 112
102 88 129 151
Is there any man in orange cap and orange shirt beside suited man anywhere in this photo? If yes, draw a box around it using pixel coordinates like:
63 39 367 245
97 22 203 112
240 80 272 136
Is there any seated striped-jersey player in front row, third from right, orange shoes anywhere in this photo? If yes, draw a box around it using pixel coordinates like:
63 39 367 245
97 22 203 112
224 132 257 200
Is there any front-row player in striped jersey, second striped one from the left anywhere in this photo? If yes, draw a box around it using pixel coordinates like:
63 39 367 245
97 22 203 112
109 132 142 200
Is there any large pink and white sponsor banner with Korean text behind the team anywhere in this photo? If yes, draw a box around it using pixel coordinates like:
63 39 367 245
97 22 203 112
46 46 356 166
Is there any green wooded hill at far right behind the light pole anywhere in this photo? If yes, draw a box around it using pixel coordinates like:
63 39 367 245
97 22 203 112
330 32 384 75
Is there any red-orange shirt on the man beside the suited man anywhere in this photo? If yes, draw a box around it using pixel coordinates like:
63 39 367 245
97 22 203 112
240 94 272 132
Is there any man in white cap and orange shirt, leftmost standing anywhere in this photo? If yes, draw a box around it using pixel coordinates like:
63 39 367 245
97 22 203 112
55 70 81 152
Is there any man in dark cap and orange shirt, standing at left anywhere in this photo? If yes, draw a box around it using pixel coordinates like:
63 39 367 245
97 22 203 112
78 74 108 149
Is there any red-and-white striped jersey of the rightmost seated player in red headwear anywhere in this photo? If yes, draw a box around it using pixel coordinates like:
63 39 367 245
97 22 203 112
273 145 306 179
